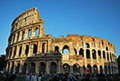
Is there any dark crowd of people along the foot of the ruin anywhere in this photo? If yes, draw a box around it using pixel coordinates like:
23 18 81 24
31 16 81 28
0 73 120 81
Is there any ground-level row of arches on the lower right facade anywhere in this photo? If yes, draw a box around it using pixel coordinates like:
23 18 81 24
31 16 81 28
63 63 115 74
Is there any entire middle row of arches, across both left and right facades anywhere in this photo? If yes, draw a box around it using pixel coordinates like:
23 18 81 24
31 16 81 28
9 43 113 61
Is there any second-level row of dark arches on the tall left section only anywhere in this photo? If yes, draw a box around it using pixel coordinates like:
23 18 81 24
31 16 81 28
8 43 47 58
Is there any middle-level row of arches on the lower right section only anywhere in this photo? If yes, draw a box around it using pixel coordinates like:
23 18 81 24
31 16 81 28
55 45 112 60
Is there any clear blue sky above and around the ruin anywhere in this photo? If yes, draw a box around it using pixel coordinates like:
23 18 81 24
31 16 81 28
0 0 120 55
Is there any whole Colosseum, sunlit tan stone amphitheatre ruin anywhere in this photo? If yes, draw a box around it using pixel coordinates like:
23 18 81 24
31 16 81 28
6 8 118 75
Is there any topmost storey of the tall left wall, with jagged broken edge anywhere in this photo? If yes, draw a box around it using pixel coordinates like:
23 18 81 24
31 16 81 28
11 8 43 32
